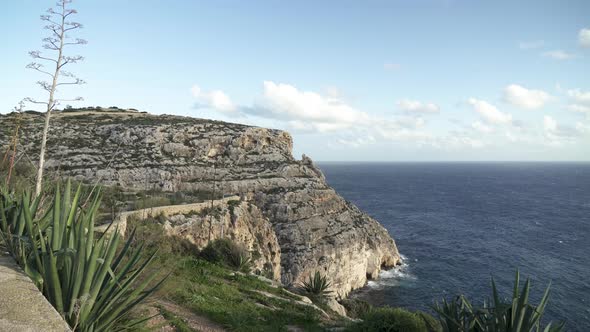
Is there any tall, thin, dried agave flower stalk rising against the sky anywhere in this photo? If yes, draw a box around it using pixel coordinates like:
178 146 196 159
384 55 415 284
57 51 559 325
26 0 87 196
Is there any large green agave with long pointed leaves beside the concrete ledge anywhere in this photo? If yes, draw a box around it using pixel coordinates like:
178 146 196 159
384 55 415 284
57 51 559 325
0 182 164 331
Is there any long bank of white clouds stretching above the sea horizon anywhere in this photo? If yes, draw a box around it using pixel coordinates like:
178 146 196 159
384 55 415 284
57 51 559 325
191 81 590 150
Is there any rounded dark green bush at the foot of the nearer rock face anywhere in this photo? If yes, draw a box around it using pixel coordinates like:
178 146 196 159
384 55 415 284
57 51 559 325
200 239 252 273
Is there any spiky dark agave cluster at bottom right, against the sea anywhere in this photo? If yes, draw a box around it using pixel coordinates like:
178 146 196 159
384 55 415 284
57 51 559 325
434 270 564 332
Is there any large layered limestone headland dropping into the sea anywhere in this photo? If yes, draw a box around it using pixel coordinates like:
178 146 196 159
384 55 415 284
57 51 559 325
0 110 400 296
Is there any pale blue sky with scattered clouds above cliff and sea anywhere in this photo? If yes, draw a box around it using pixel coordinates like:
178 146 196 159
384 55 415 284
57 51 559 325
0 0 590 161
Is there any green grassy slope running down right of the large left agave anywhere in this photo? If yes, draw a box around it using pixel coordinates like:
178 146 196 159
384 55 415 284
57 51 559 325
131 220 342 332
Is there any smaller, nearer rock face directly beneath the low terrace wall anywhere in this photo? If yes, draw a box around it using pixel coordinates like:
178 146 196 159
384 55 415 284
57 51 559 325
96 196 281 281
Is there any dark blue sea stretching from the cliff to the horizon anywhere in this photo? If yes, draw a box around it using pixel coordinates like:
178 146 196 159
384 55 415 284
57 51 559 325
319 162 590 331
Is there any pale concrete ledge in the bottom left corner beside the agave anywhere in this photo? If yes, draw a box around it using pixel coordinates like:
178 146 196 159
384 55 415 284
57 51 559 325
0 248 71 332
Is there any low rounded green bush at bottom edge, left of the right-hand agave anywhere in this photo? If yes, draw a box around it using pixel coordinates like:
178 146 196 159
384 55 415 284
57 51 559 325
348 307 440 332
